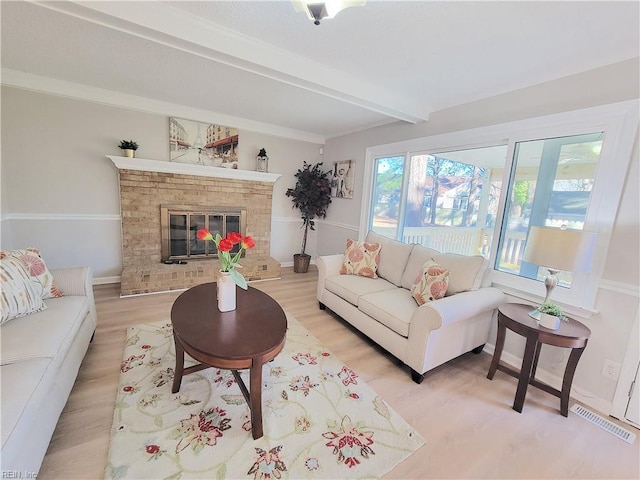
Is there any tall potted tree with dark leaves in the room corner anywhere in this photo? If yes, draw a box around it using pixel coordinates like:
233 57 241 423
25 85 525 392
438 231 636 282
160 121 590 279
286 162 331 273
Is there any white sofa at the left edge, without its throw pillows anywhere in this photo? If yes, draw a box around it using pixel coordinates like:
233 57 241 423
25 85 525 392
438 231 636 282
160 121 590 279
0 267 96 478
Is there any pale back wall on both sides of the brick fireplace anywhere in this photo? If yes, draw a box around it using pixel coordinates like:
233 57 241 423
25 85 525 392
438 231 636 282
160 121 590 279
0 87 322 283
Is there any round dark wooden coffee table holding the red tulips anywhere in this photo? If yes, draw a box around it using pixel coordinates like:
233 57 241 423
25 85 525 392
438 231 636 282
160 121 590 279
171 283 287 439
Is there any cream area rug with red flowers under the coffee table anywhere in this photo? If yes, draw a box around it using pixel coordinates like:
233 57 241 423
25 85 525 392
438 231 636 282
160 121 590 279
105 315 424 479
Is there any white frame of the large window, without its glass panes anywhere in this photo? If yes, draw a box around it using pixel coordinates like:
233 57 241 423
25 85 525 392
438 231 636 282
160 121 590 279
359 100 640 318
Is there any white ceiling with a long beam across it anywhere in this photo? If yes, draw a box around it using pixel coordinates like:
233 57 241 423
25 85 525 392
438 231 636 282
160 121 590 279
0 0 640 143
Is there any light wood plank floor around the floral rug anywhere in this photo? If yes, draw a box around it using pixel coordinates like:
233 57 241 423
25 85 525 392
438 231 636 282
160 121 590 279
38 266 640 480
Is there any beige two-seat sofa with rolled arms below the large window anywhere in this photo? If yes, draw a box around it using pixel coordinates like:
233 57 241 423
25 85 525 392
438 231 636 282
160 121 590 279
316 232 507 383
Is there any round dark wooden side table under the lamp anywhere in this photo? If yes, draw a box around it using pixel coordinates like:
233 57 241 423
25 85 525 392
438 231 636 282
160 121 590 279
487 303 591 417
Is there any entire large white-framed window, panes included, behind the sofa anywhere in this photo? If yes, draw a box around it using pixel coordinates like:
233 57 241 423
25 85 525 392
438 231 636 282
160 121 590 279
360 101 638 314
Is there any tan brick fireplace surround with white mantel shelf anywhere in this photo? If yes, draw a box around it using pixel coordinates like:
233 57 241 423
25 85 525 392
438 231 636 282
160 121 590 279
109 156 280 296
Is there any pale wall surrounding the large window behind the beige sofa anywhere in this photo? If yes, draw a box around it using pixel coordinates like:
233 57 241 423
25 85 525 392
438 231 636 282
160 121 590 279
318 59 640 413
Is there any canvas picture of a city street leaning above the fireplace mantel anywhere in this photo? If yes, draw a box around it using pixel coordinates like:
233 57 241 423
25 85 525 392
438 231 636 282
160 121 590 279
169 117 238 168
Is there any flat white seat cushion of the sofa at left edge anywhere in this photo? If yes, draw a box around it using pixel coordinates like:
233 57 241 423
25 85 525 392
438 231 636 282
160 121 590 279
0 296 89 365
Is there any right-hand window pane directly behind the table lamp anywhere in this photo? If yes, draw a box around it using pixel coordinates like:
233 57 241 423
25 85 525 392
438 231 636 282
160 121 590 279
496 132 604 287
